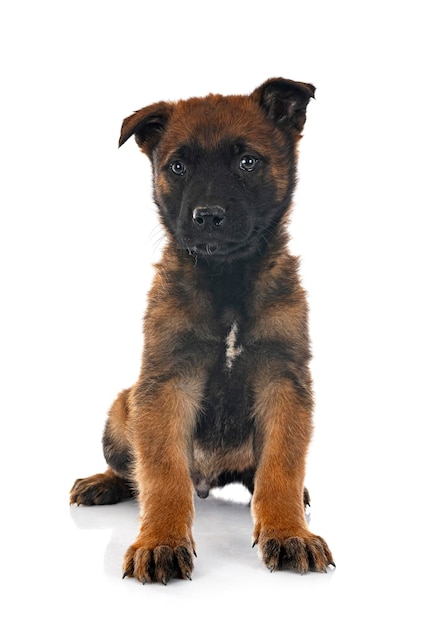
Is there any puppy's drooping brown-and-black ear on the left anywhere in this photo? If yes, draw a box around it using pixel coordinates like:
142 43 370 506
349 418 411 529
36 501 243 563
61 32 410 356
119 102 173 156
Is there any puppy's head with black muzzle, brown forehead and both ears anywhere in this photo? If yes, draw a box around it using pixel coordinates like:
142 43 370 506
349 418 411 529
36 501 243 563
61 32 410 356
119 78 315 261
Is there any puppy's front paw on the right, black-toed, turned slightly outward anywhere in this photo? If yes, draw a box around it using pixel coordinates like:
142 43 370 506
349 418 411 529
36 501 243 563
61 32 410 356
254 529 335 574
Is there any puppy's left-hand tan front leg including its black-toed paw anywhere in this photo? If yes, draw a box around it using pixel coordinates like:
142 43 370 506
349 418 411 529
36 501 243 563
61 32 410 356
123 372 201 584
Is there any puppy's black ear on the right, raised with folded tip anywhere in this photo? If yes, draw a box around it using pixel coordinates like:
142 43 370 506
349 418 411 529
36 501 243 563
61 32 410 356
252 78 316 133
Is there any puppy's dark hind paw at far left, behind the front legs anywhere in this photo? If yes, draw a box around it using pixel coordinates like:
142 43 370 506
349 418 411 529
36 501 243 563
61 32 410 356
70 472 132 506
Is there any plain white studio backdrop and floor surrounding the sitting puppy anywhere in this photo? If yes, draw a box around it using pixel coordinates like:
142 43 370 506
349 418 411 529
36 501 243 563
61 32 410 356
0 0 427 626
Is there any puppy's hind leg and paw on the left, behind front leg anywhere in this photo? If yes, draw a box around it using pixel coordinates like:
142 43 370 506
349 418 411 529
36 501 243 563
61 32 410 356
70 389 133 506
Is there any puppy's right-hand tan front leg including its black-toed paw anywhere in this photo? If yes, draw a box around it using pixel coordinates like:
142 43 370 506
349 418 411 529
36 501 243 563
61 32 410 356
252 380 333 573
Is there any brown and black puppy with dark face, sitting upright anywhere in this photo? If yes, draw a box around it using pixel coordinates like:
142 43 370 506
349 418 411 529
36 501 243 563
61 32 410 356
71 78 333 584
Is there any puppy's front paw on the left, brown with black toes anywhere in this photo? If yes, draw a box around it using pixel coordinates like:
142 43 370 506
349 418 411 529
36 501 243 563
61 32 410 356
123 539 196 585
